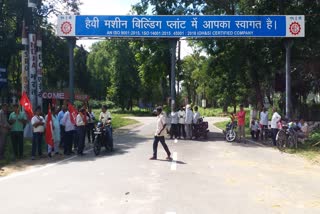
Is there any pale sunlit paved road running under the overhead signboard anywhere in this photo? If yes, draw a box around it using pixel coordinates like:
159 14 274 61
0 118 320 214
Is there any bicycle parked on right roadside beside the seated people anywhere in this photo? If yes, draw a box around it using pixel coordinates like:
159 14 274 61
276 125 298 151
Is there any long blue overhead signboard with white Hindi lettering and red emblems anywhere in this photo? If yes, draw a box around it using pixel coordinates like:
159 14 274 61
57 15 304 38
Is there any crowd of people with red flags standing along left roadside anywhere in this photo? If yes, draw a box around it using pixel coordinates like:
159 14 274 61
0 103 112 160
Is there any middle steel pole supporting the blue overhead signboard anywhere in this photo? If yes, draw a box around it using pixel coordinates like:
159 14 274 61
170 39 177 111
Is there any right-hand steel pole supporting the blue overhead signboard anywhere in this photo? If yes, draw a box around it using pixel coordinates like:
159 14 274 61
285 40 293 119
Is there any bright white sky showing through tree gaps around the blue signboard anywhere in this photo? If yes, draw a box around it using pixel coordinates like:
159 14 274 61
77 0 193 58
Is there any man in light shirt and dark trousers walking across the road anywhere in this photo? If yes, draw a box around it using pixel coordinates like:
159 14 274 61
150 107 172 160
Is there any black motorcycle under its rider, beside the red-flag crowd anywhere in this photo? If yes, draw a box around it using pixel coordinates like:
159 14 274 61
93 122 113 156
